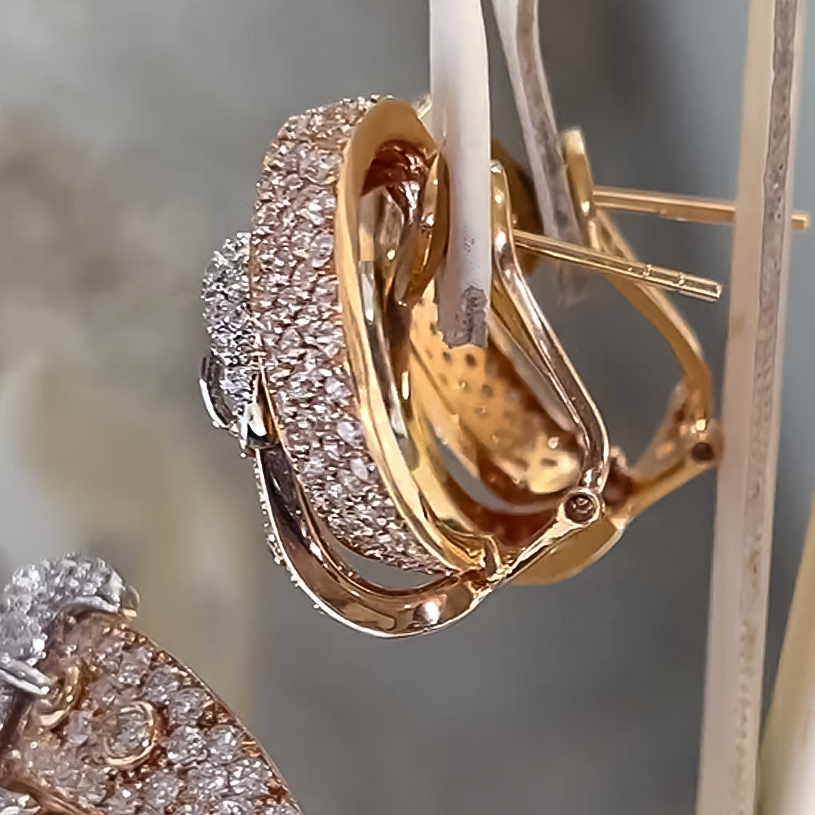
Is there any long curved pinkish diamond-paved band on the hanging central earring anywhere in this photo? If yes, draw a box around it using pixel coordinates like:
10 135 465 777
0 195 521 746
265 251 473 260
250 99 439 572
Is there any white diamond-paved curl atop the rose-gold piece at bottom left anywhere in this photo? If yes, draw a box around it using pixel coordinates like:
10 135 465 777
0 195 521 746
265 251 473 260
0 556 126 725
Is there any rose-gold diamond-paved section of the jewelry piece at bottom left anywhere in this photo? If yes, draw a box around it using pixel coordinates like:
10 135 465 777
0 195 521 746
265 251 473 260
2 614 300 815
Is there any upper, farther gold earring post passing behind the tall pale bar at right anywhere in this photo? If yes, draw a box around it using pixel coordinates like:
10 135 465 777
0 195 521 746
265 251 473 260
594 187 809 232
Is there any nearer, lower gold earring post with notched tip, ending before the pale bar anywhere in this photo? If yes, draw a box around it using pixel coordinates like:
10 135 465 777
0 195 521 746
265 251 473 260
512 229 722 303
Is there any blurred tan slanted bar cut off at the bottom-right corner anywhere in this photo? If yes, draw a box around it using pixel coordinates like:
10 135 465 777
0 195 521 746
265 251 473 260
758 504 815 815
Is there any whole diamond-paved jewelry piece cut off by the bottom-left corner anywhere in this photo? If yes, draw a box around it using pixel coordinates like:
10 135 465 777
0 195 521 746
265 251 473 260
0 557 300 815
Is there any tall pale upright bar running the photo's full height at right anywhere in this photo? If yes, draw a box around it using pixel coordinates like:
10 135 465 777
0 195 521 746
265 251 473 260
697 0 803 815
